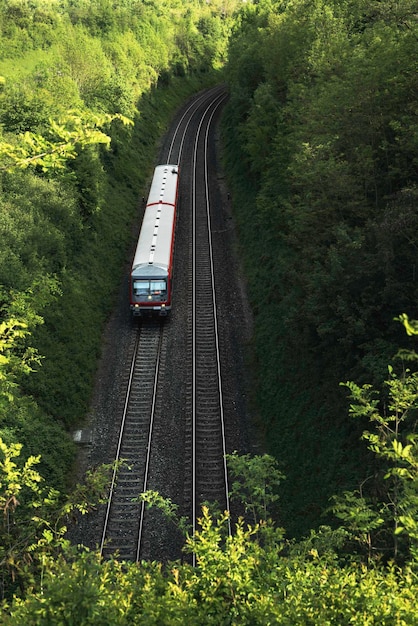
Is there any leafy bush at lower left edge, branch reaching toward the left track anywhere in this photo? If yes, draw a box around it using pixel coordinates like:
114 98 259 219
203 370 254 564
0 438 112 600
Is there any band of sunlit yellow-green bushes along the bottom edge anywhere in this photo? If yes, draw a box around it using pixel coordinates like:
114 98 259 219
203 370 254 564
4 509 418 626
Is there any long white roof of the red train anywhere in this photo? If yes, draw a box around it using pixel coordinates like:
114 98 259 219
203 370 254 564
132 165 178 277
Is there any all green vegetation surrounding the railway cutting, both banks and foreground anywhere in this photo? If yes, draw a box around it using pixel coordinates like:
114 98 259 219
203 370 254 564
0 0 418 625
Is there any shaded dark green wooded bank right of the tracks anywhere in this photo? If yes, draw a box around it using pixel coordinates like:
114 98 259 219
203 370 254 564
224 0 418 534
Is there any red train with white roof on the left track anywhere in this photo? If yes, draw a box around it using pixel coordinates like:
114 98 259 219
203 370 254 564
130 164 179 317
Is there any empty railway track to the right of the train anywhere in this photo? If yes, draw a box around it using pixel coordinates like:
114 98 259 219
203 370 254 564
186 98 229 531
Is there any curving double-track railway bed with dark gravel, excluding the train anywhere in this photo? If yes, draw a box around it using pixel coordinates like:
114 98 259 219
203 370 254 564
95 86 251 560
